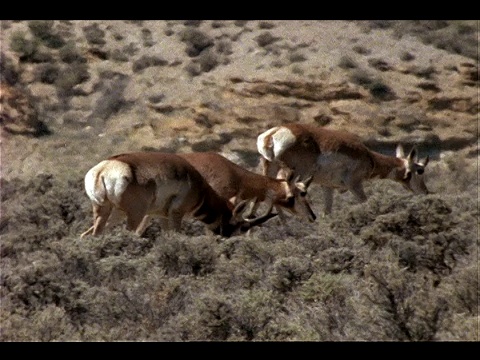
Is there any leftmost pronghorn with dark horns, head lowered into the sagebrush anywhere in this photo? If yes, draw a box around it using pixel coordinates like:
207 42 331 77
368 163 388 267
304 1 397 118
81 152 276 237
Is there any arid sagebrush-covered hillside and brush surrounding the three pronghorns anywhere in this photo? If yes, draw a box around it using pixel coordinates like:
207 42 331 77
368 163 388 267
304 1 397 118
0 20 480 341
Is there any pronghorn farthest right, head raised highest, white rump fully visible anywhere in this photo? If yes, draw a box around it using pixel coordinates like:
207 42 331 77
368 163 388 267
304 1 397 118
257 124 428 214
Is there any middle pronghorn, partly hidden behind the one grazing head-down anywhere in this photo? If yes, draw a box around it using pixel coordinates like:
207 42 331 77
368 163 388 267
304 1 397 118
177 152 316 222
